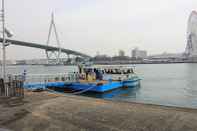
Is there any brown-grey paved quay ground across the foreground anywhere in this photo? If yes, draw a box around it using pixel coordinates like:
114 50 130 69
0 92 197 131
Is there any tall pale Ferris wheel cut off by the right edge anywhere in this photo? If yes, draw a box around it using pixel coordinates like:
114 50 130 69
185 11 197 57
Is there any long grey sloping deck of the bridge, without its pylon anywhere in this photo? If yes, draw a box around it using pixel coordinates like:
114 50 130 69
0 38 91 63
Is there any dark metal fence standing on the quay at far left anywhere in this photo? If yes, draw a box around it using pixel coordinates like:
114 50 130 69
0 76 24 97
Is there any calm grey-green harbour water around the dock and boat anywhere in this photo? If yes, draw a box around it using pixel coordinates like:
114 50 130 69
3 64 197 108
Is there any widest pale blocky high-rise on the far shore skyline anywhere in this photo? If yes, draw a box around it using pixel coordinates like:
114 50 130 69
131 48 147 59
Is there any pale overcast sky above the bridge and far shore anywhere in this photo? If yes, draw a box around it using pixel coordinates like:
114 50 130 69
1 0 197 59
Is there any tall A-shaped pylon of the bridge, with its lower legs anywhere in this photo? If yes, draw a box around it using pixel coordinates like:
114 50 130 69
45 13 61 64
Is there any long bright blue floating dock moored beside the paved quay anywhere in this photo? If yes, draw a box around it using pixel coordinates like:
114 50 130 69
24 79 140 93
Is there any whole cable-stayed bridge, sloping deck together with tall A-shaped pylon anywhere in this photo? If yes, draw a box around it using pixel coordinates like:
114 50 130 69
0 13 91 64
